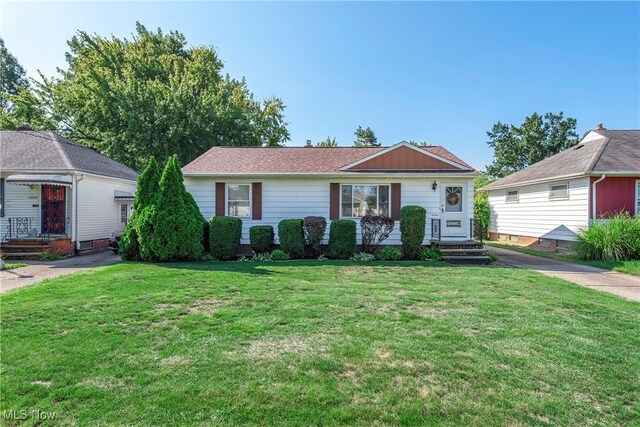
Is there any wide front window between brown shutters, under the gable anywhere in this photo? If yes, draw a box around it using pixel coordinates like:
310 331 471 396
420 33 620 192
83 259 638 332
340 184 390 218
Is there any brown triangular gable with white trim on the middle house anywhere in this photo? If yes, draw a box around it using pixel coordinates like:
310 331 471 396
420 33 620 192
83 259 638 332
340 142 471 171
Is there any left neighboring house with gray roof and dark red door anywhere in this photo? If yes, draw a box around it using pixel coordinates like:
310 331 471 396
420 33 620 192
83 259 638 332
0 127 137 254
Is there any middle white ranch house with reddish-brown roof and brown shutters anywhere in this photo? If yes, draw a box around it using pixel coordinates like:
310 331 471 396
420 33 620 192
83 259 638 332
183 142 478 244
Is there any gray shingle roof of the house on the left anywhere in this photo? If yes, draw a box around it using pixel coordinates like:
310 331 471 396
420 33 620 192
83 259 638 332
0 131 138 180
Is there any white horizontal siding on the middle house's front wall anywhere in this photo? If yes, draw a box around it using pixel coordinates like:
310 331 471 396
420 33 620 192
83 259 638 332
185 177 473 245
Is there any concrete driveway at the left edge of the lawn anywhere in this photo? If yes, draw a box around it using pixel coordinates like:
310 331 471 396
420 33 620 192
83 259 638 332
0 251 120 293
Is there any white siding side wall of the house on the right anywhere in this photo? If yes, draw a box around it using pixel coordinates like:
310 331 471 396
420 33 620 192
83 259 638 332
489 178 589 240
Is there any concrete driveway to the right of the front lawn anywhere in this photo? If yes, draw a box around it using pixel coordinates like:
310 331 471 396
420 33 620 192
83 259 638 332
487 246 640 301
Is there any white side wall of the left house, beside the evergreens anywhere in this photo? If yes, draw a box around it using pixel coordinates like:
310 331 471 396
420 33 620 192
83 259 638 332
77 174 136 242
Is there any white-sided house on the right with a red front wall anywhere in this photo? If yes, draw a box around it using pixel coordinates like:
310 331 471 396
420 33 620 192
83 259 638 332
481 126 640 249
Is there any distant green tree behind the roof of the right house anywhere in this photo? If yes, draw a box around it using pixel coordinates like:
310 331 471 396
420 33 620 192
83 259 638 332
486 111 578 178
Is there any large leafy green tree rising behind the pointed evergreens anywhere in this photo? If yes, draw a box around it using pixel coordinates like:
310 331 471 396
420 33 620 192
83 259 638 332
1 24 289 169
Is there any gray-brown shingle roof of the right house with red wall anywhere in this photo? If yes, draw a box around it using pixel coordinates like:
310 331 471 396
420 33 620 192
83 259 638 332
482 130 640 190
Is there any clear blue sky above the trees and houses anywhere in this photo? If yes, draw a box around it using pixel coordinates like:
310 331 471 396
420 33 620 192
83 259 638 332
0 2 640 168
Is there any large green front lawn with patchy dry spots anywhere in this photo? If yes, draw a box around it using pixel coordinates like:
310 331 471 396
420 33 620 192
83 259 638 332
0 261 640 426
